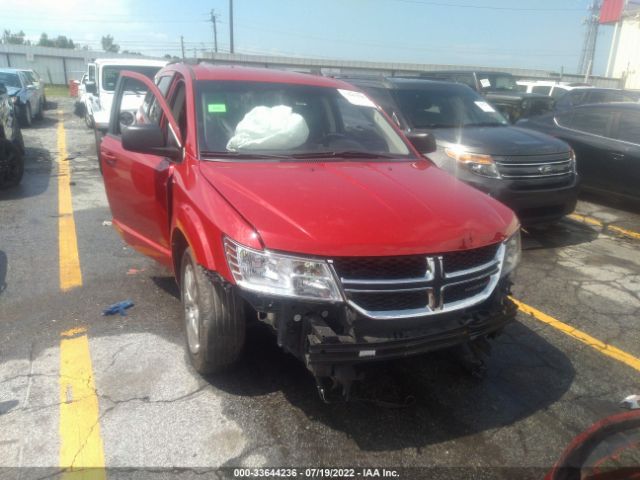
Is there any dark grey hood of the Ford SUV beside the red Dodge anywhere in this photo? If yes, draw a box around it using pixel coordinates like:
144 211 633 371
429 125 570 156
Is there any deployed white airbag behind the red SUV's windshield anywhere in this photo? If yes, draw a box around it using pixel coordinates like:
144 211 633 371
227 105 309 152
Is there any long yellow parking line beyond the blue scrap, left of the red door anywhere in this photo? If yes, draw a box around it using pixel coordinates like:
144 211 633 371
57 110 82 292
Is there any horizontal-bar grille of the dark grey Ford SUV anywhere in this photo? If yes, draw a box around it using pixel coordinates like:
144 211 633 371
496 153 574 183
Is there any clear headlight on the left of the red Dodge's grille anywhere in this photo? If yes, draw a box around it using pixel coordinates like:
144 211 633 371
224 238 342 301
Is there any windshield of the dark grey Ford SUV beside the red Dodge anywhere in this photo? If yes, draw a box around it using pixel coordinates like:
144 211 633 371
393 87 508 128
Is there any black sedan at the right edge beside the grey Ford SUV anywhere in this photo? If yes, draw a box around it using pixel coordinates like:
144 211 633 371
518 103 640 202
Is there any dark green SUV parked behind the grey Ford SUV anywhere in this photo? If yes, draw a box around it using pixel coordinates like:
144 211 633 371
420 70 554 123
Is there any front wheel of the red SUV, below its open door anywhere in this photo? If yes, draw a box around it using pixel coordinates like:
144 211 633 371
180 248 246 374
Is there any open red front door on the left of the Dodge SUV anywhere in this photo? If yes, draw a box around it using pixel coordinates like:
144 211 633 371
100 72 182 265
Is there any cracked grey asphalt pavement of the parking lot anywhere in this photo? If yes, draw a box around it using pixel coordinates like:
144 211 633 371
0 98 640 479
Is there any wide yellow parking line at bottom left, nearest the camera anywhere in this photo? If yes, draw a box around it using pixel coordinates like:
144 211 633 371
60 328 106 480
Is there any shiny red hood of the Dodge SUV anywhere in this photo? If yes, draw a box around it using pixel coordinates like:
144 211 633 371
200 160 516 256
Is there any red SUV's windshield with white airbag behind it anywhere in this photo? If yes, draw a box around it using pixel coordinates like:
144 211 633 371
197 81 413 158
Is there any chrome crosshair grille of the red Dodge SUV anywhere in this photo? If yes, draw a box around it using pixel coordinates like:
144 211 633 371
330 244 504 319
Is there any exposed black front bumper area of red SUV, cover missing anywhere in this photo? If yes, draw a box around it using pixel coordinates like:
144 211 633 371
229 277 517 401
